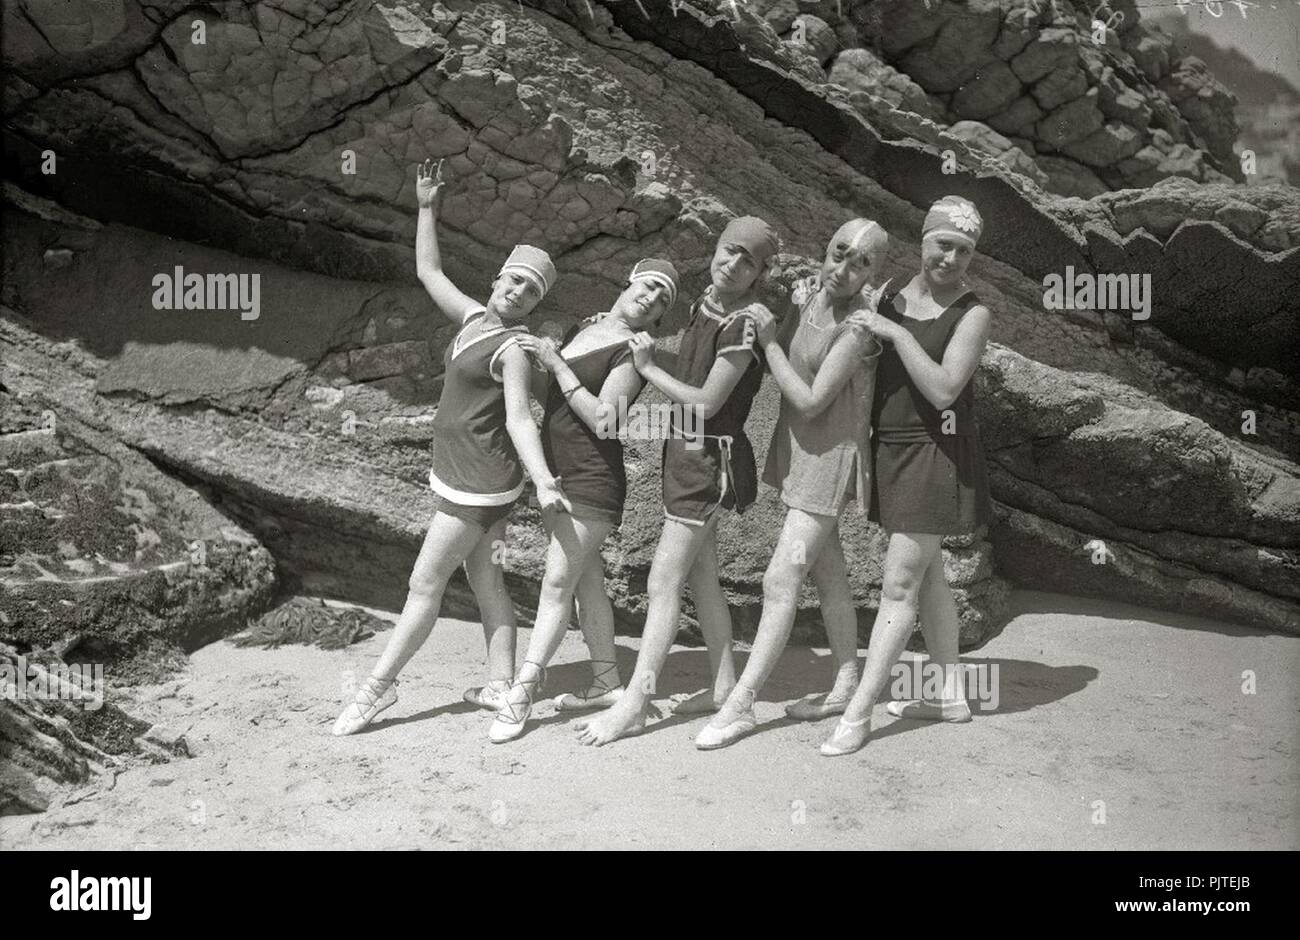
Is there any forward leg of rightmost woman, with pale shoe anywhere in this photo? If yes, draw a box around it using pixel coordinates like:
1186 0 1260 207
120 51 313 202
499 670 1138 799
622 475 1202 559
823 532 943 754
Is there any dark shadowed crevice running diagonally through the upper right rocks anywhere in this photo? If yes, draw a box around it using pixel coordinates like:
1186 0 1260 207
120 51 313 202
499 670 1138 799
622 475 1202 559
569 0 1300 380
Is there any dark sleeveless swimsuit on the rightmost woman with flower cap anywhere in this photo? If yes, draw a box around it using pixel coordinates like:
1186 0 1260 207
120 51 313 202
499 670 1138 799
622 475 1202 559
870 282 992 536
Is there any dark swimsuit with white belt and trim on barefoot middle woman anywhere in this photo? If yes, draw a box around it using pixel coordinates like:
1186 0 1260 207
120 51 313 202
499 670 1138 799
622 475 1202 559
663 289 766 525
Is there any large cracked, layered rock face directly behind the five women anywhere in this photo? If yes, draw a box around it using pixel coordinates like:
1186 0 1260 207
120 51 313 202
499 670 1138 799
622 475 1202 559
0 0 1300 717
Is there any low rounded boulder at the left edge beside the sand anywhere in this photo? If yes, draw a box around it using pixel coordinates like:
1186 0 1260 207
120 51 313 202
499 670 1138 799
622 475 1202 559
0 355 276 677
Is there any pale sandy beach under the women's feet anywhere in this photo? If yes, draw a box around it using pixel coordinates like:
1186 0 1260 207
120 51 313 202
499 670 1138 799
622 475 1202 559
0 592 1300 850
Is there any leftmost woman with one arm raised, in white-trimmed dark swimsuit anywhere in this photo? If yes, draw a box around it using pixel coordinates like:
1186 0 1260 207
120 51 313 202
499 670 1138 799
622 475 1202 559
334 160 568 735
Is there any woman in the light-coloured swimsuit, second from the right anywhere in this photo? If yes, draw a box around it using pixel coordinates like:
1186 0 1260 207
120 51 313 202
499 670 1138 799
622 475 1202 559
696 218 889 750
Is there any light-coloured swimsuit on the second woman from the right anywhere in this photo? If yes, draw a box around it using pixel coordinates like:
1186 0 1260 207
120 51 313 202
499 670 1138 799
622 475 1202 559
763 279 881 516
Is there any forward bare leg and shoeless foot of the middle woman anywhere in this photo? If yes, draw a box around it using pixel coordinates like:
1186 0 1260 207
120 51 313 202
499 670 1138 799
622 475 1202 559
577 516 716 746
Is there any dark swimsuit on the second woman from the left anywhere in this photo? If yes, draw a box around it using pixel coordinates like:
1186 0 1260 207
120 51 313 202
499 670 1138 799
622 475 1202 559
542 320 640 525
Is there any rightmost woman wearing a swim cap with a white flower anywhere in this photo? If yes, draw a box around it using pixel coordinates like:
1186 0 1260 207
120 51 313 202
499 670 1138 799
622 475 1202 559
822 196 993 757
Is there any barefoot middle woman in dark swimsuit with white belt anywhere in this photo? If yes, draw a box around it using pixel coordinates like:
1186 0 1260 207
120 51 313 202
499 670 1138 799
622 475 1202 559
576 216 780 746
